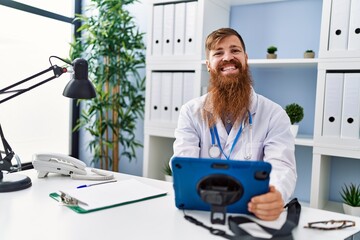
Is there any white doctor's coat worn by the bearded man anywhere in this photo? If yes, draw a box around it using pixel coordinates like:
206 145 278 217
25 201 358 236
174 91 297 202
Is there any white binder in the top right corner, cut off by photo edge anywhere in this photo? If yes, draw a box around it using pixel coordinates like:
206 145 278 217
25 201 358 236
348 0 360 50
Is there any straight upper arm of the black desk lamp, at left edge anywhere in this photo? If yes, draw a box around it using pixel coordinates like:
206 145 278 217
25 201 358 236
0 65 67 104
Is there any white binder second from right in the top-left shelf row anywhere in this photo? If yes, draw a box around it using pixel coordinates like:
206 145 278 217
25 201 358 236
174 2 186 55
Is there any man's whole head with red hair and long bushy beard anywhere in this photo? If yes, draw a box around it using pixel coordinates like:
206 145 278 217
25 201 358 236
204 28 252 127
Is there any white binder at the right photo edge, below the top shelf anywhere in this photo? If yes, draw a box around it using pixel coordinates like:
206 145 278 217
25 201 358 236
341 73 360 139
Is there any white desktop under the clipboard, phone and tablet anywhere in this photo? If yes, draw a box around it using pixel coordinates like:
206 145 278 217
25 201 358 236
0 170 360 240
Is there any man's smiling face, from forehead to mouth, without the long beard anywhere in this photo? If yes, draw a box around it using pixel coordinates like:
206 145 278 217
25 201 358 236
206 35 247 76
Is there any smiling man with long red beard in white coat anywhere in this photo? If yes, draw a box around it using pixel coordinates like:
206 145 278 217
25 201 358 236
174 28 297 220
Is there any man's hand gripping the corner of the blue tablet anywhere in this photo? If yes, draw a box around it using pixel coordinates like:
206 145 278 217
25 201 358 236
248 186 284 221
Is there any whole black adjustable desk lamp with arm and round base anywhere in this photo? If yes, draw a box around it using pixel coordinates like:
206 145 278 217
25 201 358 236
0 56 96 192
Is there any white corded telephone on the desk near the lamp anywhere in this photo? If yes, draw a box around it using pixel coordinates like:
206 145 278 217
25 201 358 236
33 153 114 180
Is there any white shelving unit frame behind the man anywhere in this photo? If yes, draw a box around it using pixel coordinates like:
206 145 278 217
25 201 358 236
143 0 360 212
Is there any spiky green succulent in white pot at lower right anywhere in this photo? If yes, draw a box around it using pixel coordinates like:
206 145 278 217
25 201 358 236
340 183 360 217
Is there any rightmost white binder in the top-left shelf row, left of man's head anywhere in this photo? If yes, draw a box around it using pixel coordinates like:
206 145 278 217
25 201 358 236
185 2 197 55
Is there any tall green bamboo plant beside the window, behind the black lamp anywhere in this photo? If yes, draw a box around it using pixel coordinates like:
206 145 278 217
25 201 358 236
71 0 145 172
